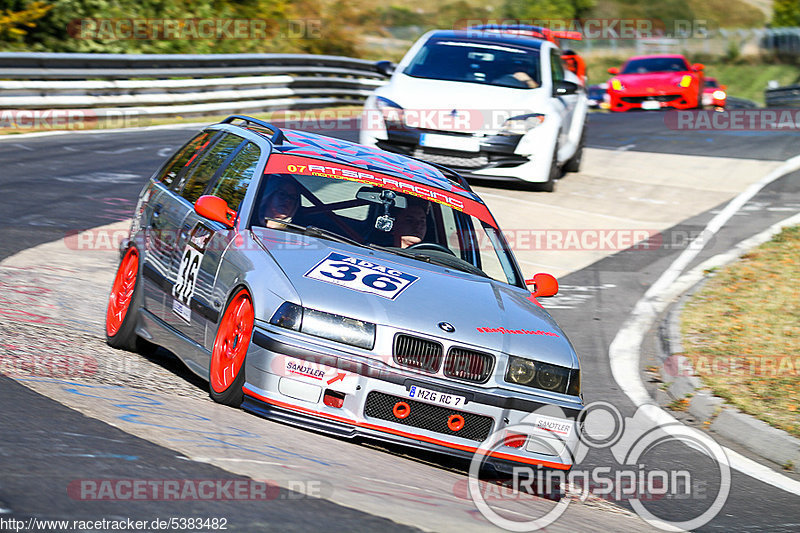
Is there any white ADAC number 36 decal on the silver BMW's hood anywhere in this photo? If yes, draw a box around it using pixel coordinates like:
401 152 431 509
305 252 419 300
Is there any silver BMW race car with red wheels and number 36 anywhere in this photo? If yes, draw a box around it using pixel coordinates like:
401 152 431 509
106 116 583 471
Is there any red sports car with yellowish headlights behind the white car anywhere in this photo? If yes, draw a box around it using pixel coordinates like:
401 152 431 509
608 54 703 111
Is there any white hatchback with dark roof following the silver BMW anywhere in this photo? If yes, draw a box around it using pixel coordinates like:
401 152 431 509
360 29 588 191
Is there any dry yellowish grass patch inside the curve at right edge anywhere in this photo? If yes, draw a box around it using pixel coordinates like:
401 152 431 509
681 226 800 437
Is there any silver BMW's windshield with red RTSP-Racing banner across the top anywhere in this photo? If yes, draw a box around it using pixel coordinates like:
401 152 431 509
251 154 524 287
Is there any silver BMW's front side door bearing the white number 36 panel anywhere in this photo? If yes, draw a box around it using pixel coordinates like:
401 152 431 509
165 133 253 350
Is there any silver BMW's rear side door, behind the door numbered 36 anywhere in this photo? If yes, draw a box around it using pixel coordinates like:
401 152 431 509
141 131 215 319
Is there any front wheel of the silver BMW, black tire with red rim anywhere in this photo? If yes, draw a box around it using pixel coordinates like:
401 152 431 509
208 288 255 407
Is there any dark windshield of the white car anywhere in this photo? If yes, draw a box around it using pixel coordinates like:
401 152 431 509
403 39 542 89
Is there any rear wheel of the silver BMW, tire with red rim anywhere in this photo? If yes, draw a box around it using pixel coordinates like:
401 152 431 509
106 247 152 354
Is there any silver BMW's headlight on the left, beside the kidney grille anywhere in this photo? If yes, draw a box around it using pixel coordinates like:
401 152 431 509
269 302 375 350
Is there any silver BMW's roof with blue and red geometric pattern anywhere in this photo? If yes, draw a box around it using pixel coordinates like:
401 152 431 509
216 115 483 204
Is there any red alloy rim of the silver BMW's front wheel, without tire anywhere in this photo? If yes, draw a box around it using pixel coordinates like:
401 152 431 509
209 289 255 393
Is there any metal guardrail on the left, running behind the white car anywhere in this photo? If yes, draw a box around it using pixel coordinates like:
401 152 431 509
0 53 386 118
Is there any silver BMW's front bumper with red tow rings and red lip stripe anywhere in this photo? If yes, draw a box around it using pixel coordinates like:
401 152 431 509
243 327 583 472
